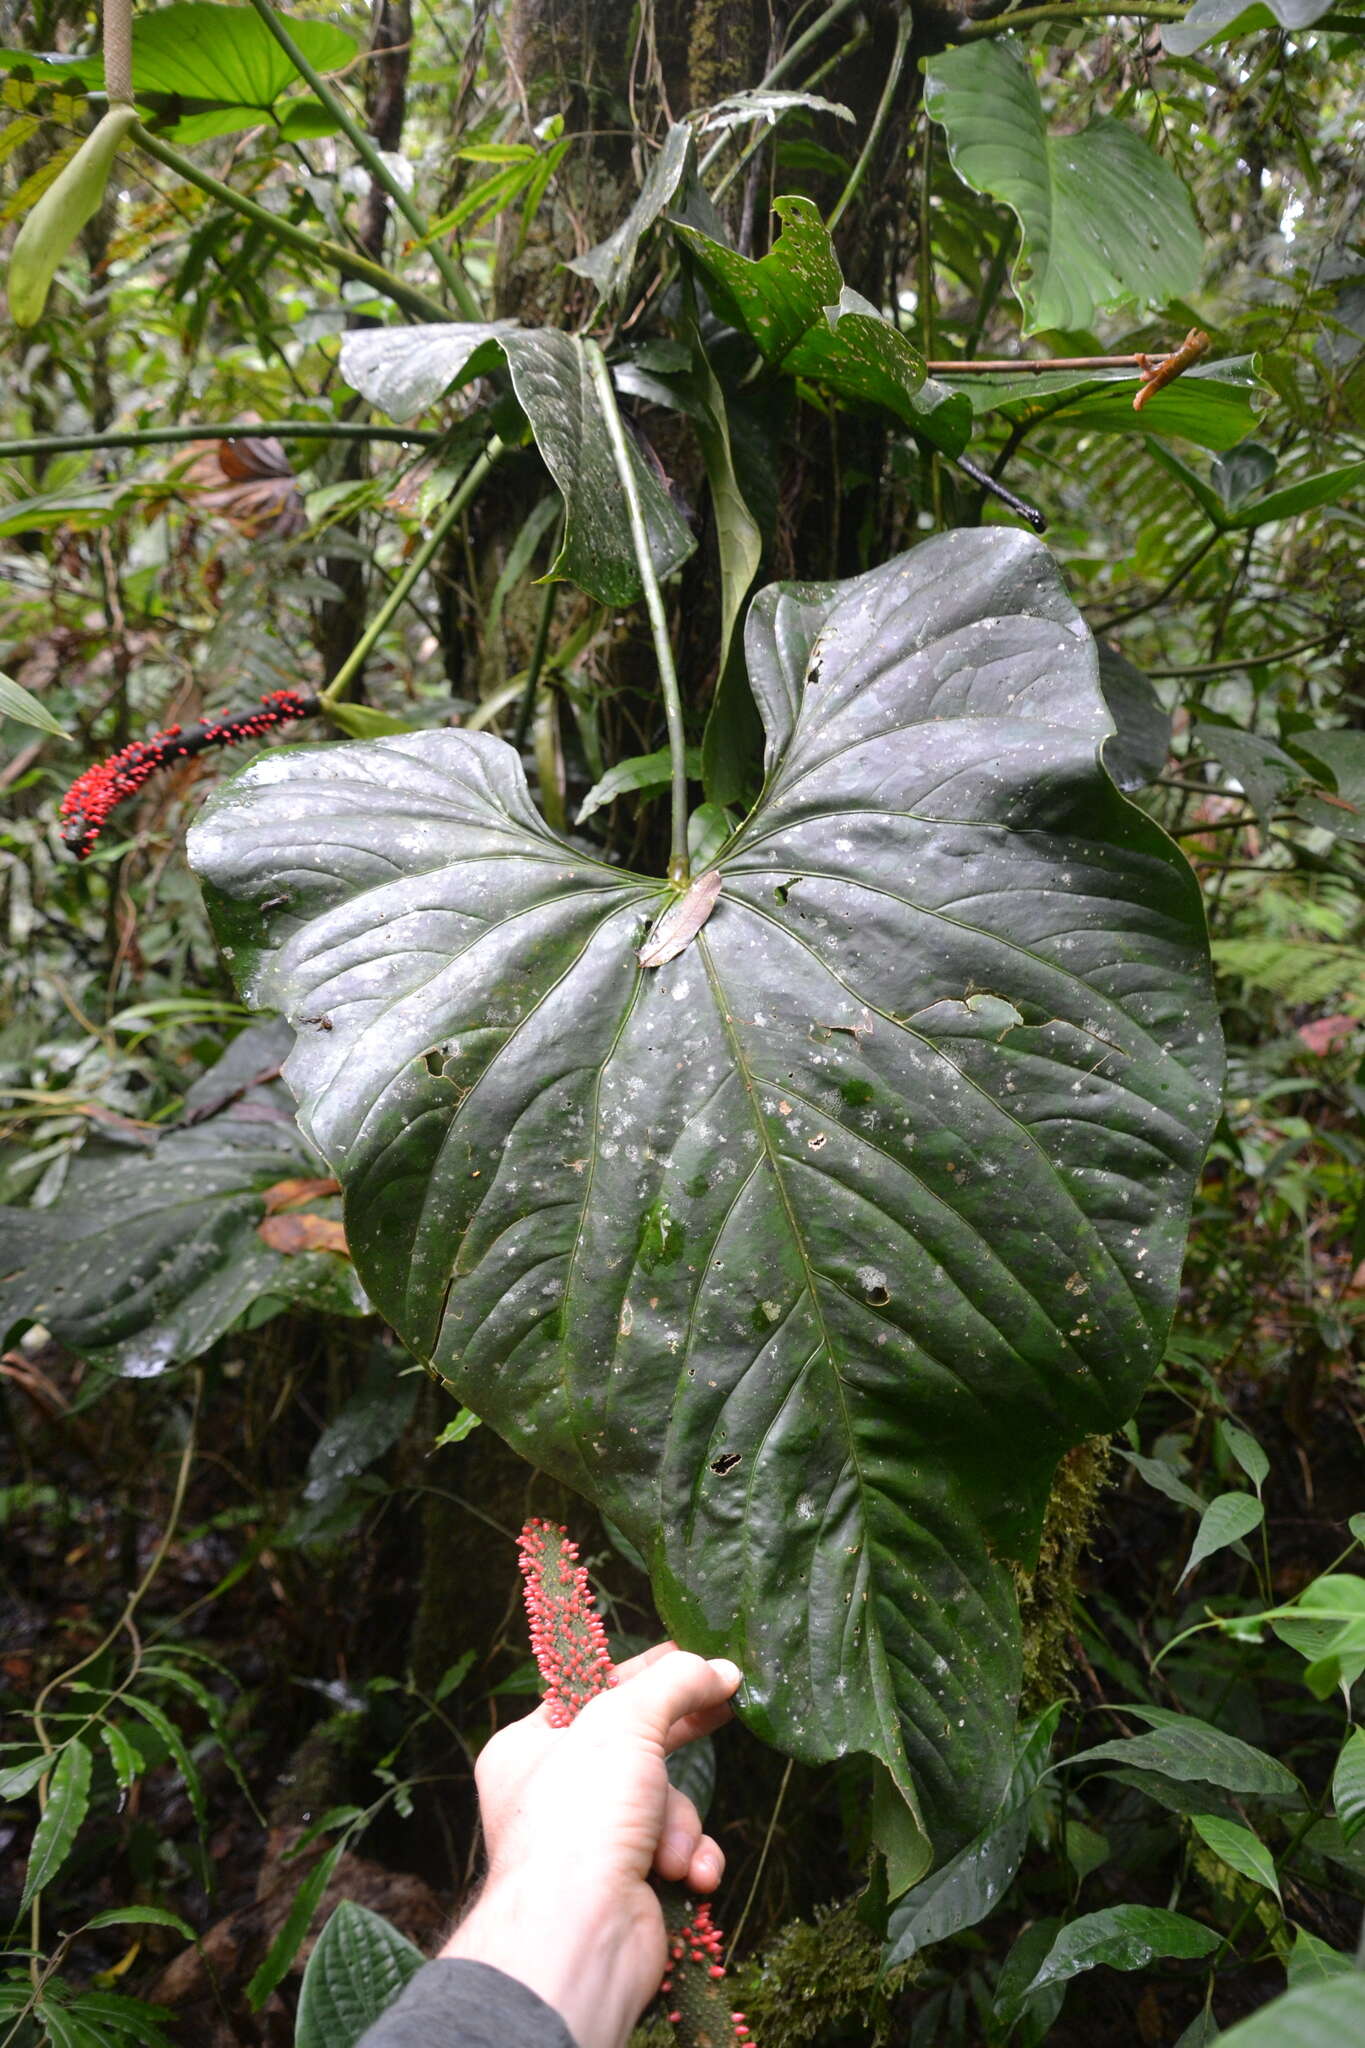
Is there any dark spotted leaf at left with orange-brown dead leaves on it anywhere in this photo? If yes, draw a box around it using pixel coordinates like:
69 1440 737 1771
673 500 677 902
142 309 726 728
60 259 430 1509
0 1024 368 1378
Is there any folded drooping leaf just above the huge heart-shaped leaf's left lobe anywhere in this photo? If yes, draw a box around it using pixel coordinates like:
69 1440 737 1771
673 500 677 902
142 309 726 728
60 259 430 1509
342 319 696 604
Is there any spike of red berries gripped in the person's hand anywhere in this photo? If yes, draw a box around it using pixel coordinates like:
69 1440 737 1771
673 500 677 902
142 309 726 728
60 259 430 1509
518 1520 753 2048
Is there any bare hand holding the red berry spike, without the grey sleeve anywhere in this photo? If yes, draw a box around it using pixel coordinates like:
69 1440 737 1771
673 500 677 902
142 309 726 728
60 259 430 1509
440 1642 739 2048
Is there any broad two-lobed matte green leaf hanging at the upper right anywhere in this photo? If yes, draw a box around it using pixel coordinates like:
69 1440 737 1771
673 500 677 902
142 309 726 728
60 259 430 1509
925 41 1201 334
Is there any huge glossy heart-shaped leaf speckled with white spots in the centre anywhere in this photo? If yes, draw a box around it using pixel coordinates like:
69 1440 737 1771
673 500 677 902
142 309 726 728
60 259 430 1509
190 528 1220 1874
